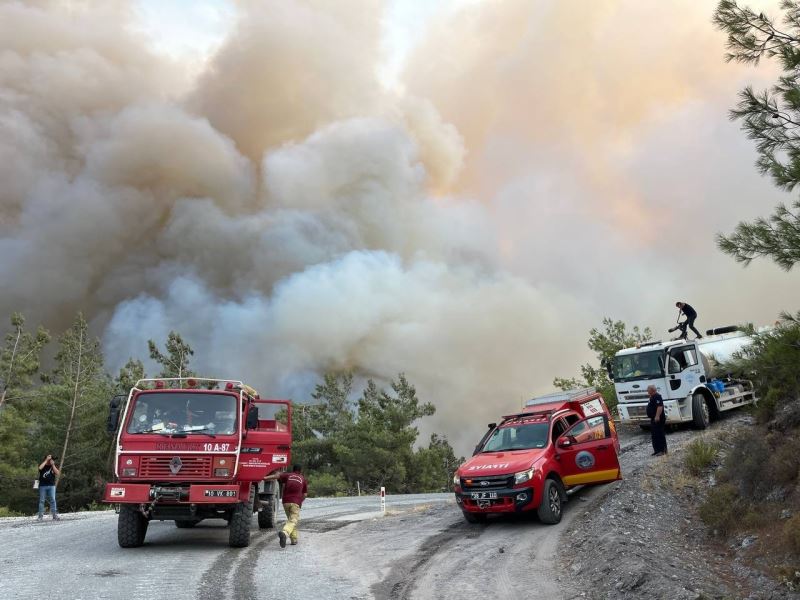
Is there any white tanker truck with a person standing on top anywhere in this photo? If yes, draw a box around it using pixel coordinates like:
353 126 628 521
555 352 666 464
608 326 758 429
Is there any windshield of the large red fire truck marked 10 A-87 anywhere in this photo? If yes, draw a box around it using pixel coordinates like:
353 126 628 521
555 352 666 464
126 392 238 435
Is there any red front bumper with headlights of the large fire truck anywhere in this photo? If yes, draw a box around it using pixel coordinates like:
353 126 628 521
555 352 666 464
103 483 240 504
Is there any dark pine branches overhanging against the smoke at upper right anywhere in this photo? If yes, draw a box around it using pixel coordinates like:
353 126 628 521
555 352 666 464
713 0 800 271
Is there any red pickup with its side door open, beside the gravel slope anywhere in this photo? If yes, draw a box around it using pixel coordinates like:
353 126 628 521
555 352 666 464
453 389 620 524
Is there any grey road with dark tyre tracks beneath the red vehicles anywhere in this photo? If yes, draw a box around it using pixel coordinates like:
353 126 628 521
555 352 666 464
0 422 732 600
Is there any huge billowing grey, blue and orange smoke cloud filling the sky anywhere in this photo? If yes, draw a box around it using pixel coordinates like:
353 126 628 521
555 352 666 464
0 0 800 453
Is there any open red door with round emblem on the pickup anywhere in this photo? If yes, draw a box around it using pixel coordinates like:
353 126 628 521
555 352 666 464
555 415 622 487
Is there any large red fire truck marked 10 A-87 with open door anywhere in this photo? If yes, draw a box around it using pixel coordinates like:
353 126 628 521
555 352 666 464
103 378 292 548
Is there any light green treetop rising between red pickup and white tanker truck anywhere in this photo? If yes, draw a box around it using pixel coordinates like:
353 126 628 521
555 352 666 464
553 317 653 408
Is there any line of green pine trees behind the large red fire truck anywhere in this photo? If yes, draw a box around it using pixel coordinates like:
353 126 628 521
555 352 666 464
0 313 460 517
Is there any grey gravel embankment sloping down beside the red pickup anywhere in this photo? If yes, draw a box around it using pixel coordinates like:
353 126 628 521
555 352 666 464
558 414 800 600
